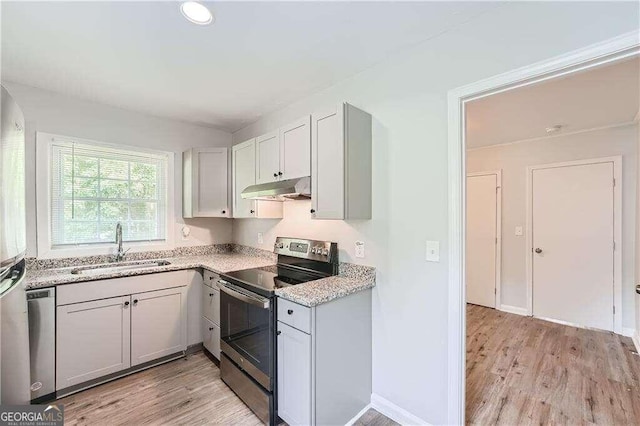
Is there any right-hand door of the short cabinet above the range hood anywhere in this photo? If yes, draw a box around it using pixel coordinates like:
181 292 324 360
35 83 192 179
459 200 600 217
280 116 311 179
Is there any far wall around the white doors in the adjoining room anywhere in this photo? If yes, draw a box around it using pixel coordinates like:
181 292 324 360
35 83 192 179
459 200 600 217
467 124 638 328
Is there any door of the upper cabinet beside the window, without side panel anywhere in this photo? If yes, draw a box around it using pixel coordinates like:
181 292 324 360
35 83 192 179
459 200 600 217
192 148 230 217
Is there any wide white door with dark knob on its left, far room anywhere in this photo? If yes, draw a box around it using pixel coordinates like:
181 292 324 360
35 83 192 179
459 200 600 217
531 162 614 330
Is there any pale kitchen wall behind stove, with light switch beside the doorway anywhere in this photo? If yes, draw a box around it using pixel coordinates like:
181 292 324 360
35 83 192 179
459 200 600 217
233 2 638 424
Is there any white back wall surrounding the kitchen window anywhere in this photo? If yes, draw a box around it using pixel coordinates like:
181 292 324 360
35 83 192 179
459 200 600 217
2 81 232 256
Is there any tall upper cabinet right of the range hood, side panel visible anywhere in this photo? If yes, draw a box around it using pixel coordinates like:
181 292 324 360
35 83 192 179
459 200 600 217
311 103 371 220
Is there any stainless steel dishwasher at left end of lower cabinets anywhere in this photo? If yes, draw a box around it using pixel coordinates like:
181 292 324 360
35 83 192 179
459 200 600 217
27 288 56 404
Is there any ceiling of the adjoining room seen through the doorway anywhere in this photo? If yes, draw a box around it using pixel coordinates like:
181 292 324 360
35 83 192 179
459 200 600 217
466 57 640 148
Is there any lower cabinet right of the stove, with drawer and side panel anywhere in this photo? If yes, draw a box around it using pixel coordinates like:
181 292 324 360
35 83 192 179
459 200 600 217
277 290 371 426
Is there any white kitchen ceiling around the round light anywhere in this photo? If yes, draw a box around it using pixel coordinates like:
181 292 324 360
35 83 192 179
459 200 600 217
1 1 497 131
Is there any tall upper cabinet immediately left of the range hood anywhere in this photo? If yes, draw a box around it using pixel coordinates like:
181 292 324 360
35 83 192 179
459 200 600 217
231 138 282 219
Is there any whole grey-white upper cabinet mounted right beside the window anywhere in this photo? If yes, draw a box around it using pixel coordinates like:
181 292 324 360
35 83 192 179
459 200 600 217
182 148 231 218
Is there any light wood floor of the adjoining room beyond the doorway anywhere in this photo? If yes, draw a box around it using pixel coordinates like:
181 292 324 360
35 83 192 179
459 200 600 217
466 305 640 425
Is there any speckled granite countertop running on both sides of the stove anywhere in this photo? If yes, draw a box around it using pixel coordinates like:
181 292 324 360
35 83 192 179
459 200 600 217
25 247 376 307
